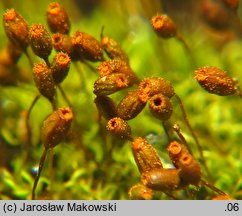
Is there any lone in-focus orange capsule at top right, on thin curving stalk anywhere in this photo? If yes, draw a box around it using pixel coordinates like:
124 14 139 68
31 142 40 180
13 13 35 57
151 15 177 39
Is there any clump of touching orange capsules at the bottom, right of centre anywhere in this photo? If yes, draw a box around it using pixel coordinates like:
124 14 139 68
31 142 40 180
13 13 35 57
129 137 202 199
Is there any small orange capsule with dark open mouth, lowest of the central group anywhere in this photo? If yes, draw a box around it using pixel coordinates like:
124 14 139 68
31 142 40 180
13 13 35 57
107 117 131 139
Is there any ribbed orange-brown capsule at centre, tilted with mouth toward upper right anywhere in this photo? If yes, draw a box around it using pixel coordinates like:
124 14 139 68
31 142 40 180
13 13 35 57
117 90 147 120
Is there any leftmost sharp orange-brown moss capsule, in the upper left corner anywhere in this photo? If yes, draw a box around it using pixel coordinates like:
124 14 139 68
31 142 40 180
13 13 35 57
3 9 29 51
